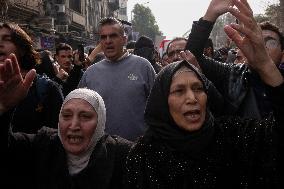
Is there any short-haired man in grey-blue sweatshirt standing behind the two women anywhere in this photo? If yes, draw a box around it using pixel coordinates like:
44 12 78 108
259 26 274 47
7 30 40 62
78 17 155 141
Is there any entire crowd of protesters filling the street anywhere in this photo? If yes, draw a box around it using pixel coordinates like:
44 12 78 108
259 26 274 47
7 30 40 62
0 0 284 189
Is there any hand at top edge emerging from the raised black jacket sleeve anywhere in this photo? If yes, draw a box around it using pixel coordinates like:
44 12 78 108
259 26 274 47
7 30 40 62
203 0 233 22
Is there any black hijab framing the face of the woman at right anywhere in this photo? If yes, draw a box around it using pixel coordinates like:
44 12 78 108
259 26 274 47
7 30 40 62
144 61 214 154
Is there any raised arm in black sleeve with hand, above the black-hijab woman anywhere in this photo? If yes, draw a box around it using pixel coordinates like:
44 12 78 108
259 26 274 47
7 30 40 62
186 0 247 97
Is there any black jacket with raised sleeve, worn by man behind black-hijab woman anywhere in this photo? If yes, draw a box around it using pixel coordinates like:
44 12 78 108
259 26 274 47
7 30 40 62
186 19 282 119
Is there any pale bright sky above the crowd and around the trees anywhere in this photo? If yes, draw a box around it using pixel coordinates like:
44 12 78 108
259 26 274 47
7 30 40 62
127 0 279 39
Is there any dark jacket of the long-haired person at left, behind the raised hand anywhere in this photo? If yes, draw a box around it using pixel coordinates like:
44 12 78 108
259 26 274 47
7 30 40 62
11 75 63 133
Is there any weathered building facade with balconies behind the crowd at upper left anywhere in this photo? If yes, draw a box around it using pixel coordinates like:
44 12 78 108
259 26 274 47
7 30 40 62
0 0 127 51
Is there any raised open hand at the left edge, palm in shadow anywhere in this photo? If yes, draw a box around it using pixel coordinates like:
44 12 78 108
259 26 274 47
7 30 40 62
0 54 36 113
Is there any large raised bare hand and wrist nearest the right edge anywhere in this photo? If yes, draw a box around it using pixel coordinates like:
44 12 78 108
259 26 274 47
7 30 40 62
224 0 283 86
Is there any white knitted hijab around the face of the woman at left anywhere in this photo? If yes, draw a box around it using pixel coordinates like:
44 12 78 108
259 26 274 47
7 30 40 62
58 88 106 175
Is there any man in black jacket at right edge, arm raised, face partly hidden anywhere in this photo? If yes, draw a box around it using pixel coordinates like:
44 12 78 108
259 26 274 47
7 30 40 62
185 0 284 119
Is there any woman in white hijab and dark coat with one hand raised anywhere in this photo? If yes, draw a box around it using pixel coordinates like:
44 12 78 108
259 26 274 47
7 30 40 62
0 61 132 189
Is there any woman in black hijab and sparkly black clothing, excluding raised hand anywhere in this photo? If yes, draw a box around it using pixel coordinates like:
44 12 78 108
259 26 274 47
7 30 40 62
126 58 284 189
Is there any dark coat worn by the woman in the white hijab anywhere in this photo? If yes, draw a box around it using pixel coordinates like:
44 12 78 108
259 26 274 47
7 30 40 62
7 125 131 189
